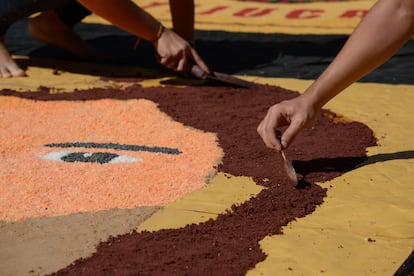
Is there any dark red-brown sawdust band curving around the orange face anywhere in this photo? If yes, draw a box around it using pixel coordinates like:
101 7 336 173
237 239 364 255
1 83 376 275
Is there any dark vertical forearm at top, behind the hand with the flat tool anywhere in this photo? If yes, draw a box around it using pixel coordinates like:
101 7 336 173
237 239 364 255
170 0 194 41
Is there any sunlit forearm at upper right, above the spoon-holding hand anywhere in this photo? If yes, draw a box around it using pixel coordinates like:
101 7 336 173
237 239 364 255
304 0 414 109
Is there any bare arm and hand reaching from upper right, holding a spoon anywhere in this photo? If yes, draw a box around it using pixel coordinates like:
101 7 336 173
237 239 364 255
257 0 414 150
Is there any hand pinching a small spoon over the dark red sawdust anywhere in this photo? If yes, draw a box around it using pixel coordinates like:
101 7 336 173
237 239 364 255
257 95 317 151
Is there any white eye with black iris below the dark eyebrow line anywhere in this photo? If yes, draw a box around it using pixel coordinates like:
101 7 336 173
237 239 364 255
41 151 142 164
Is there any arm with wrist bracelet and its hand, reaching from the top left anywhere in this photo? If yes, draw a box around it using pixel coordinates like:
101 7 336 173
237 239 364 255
78 0 209 72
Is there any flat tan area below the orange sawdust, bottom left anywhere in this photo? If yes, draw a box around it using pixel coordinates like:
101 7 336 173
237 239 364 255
0 207 160 276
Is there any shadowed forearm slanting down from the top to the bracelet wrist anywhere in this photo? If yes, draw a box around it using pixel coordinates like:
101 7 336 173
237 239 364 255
78 0 160 40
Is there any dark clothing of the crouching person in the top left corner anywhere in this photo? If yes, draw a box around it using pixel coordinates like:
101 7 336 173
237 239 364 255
0 0 69 35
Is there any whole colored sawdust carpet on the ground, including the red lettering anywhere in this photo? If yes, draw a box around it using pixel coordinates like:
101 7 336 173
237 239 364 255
0 0 414 275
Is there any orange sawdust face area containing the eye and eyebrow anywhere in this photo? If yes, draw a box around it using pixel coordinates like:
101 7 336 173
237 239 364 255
0 97 222 221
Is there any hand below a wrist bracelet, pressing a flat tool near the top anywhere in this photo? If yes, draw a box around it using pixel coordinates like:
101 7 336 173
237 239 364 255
154 29 210 74
